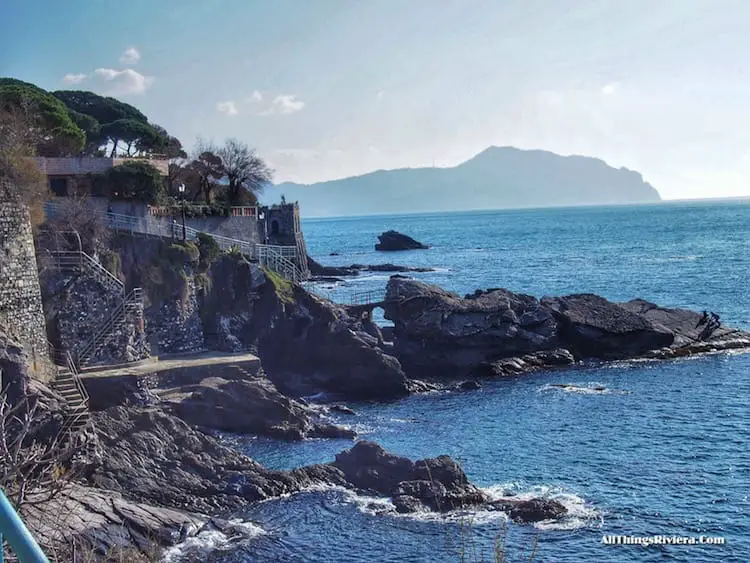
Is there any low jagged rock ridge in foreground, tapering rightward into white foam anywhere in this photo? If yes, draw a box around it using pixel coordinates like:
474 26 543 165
90 407 566 522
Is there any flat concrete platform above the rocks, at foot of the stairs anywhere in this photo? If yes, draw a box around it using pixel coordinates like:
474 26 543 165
81 352 260 379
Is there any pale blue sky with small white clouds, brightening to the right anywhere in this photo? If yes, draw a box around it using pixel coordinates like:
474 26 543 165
0 0 750 199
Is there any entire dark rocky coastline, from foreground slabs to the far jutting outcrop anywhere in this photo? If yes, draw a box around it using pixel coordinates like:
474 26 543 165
5 262 750 552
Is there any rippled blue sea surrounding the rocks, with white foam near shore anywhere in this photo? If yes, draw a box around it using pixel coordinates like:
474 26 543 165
171 203 750 563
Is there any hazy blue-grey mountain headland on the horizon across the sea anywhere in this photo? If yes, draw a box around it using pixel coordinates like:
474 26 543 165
265 147 661 216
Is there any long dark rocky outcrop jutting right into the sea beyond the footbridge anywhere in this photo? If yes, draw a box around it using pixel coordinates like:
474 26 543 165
384 276 750 377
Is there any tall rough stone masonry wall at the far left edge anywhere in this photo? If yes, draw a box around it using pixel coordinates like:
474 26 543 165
0 180 54 381
